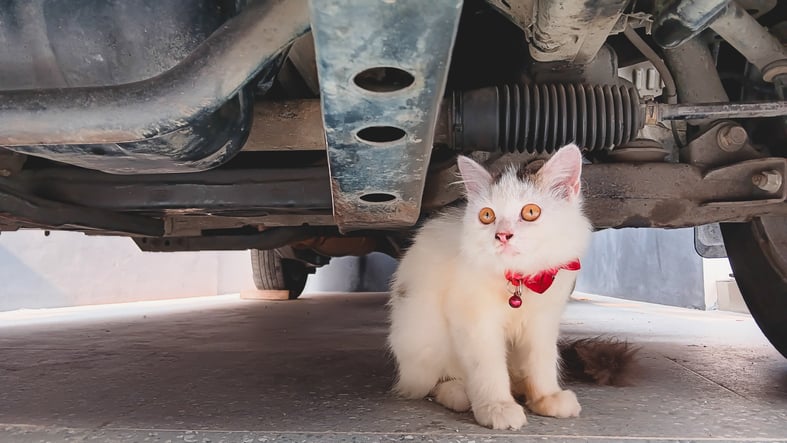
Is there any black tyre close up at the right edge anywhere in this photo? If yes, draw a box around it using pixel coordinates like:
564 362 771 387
721 217 787 357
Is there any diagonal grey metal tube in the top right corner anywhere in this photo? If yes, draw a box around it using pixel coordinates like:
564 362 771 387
710 1 787 82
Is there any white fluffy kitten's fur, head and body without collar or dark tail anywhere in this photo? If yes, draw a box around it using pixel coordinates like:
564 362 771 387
389 145 591 429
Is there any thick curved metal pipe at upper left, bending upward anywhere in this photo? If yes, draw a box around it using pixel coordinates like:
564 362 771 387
0 0 309 146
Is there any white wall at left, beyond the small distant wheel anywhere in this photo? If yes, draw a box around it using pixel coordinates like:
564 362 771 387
0 231 253 311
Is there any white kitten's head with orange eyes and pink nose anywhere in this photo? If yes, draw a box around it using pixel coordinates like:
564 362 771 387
459 145 590 274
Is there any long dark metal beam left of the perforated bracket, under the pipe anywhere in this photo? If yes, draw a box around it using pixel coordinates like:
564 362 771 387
15 167 331 215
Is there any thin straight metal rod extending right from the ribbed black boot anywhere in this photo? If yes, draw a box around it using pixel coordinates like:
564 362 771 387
646 101 787 120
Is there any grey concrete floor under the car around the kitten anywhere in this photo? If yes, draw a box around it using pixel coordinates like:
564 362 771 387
0 294 787 443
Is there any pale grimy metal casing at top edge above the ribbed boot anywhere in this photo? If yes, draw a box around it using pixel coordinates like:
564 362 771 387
530 0 628 65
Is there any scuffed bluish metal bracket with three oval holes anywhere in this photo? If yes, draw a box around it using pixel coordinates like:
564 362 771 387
310 0 462 232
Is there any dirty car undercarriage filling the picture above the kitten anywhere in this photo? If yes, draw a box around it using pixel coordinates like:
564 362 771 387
0 0 787 355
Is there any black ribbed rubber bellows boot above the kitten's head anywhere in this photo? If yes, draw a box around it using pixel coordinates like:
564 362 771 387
449 84 644 153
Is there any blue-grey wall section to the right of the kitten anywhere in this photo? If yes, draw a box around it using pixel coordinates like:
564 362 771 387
577 229 710 309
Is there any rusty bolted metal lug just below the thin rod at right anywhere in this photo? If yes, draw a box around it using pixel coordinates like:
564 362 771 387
680 121 764 168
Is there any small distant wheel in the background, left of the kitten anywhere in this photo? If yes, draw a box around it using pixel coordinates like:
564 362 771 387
251 249 309 300
